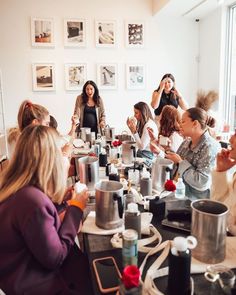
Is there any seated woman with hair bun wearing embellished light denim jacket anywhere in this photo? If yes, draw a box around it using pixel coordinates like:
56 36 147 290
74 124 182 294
166 107 220 199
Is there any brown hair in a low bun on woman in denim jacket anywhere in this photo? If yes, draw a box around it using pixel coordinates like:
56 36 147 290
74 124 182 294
186 107 215 130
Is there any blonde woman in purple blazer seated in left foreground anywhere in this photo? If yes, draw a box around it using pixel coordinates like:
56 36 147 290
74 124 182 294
0 124 91 295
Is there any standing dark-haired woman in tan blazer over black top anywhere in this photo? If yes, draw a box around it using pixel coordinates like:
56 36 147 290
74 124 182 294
74 81 106 134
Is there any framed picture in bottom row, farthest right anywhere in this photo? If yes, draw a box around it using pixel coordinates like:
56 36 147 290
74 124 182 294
126 64 146 89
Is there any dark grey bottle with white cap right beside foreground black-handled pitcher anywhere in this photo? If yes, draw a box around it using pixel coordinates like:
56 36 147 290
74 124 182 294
125 203 141 239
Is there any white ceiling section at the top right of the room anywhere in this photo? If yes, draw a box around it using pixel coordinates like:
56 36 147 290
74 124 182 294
154 0 224 19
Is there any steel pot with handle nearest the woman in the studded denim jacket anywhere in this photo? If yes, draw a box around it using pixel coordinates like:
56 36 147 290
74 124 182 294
152 158 174 192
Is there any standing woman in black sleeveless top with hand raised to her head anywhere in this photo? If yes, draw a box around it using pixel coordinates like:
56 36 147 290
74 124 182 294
151 74 187 121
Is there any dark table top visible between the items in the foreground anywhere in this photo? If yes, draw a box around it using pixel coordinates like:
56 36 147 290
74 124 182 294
80 199 234 295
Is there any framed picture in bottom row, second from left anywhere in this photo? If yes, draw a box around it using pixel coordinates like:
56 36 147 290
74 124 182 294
65 63 87 90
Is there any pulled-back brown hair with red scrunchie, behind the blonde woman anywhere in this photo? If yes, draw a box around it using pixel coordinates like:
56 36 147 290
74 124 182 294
17 100 49 131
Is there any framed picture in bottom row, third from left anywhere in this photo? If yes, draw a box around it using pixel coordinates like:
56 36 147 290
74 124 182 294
97 63 117 89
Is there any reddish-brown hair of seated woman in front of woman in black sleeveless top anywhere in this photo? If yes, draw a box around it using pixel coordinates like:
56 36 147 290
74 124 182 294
159 105 181 137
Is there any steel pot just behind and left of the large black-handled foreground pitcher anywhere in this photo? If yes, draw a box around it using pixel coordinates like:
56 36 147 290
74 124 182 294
75 156 99 190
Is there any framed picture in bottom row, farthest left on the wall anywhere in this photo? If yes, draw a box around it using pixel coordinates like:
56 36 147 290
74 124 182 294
32 63 55 91
